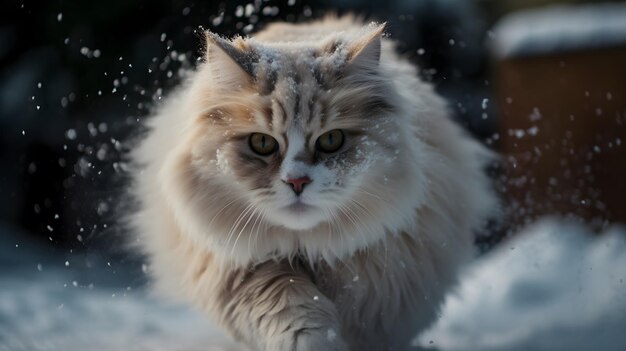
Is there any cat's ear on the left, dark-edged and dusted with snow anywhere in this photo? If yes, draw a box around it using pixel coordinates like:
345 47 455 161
205 31 258 83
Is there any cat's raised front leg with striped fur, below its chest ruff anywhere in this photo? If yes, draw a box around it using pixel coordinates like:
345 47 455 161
216 261 348 351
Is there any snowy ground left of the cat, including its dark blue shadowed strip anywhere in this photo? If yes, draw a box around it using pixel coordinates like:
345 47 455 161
0 222 243 351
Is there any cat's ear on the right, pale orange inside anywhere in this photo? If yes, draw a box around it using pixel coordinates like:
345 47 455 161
347 23 386 70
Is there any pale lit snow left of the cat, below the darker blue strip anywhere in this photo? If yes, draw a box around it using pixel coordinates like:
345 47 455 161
0 274 241 351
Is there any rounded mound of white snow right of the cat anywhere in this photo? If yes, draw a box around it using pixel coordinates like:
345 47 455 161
419 220 626 351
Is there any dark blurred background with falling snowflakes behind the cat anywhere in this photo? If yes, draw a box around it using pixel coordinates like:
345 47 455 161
0 0 626 349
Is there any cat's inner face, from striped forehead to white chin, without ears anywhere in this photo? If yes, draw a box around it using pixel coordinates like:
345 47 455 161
216 82 393 230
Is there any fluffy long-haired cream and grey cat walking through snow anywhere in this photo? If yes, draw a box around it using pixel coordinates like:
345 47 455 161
133 17 496 351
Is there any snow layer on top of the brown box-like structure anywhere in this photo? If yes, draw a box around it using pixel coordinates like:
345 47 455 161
491 3 626 58
